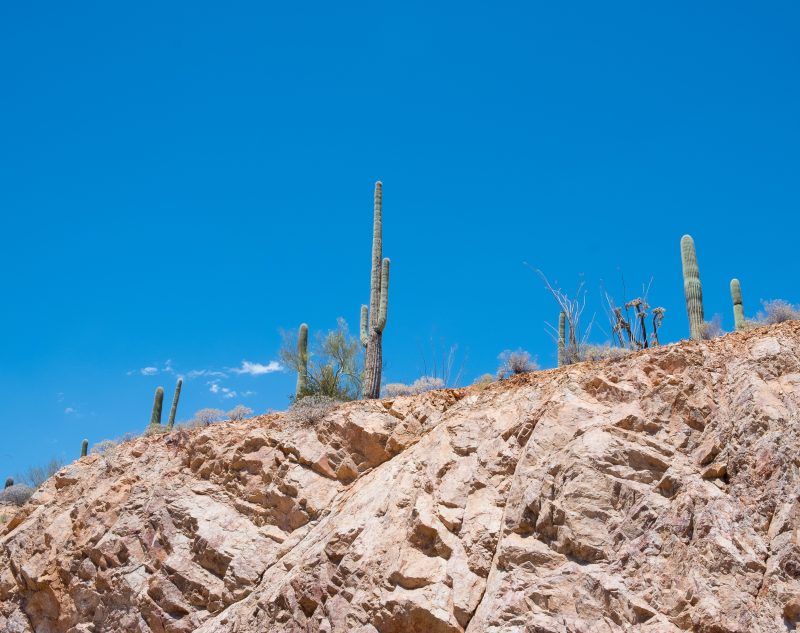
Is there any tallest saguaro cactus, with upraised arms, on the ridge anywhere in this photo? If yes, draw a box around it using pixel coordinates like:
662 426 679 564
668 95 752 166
361 180 389 398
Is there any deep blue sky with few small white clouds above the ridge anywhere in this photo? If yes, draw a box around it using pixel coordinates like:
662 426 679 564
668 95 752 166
0 2 800 476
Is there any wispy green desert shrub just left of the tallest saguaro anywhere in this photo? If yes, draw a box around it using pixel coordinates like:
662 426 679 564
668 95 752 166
280 318 362 401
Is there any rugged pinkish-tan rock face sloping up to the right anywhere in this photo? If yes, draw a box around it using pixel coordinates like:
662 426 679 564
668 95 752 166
0 323 800 633
